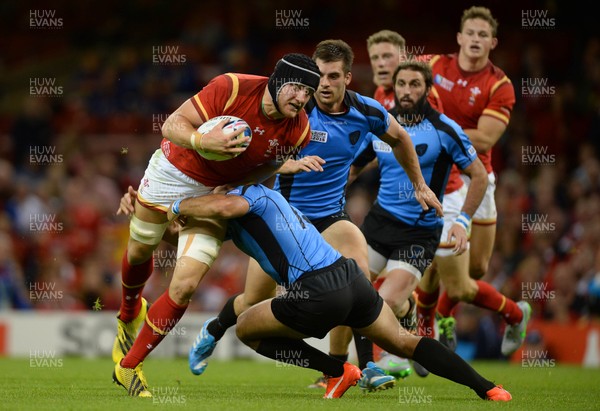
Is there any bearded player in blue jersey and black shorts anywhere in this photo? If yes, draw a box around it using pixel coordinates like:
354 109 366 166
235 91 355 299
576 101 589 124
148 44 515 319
352 61 487 375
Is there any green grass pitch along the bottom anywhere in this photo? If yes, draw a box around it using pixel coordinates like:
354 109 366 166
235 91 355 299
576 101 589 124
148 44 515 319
0 358 600 411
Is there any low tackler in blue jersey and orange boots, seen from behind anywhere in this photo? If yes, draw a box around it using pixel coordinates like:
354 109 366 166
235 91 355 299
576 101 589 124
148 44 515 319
163 185 511 401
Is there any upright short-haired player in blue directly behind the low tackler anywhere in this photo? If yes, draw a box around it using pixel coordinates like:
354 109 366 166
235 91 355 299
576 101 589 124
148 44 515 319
190 40 441 390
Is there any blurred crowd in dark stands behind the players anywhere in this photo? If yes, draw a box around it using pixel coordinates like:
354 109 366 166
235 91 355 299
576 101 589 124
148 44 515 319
0 0 600 357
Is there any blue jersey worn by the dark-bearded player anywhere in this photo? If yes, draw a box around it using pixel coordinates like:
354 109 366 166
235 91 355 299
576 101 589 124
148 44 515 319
354 103 477 228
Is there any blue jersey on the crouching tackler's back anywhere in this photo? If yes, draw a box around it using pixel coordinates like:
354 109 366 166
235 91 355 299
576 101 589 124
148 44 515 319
228 185 342 285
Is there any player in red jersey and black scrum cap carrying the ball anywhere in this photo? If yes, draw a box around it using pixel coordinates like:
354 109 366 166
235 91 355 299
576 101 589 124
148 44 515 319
113 54 320 389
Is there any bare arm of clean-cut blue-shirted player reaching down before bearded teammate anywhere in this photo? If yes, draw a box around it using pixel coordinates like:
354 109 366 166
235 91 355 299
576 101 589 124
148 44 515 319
378 113 444 216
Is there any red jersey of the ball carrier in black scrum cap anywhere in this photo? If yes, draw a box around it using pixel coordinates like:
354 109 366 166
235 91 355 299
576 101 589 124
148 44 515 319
161 73 310 187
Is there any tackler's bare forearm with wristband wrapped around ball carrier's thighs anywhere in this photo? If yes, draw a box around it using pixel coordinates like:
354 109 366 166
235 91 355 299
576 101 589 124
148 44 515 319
167 194 250 221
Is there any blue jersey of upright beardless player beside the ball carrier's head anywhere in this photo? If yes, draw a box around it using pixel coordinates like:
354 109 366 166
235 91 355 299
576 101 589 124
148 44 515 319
275 90 390 220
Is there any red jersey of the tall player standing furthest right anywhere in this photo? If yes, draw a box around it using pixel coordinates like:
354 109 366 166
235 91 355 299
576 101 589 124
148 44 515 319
430 53 515 193
